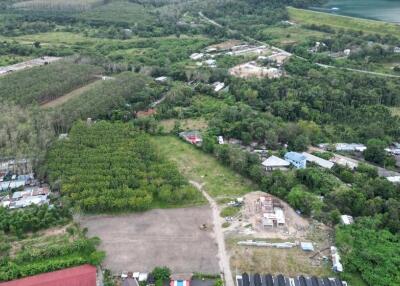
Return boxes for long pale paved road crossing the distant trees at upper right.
[199,12,400,78]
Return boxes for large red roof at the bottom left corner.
[0,264,96,286]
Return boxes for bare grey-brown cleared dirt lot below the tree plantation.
[81,207,219,273]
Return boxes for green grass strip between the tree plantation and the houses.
[153,136,255,198]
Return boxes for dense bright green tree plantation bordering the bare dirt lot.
[47,121,200,212]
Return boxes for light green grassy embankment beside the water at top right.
[287,7,400,37]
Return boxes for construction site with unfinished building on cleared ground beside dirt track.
[225,192,333,276]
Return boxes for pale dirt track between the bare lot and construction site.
[190,181,235,286]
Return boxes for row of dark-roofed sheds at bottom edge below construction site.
[236,273,347,286]
